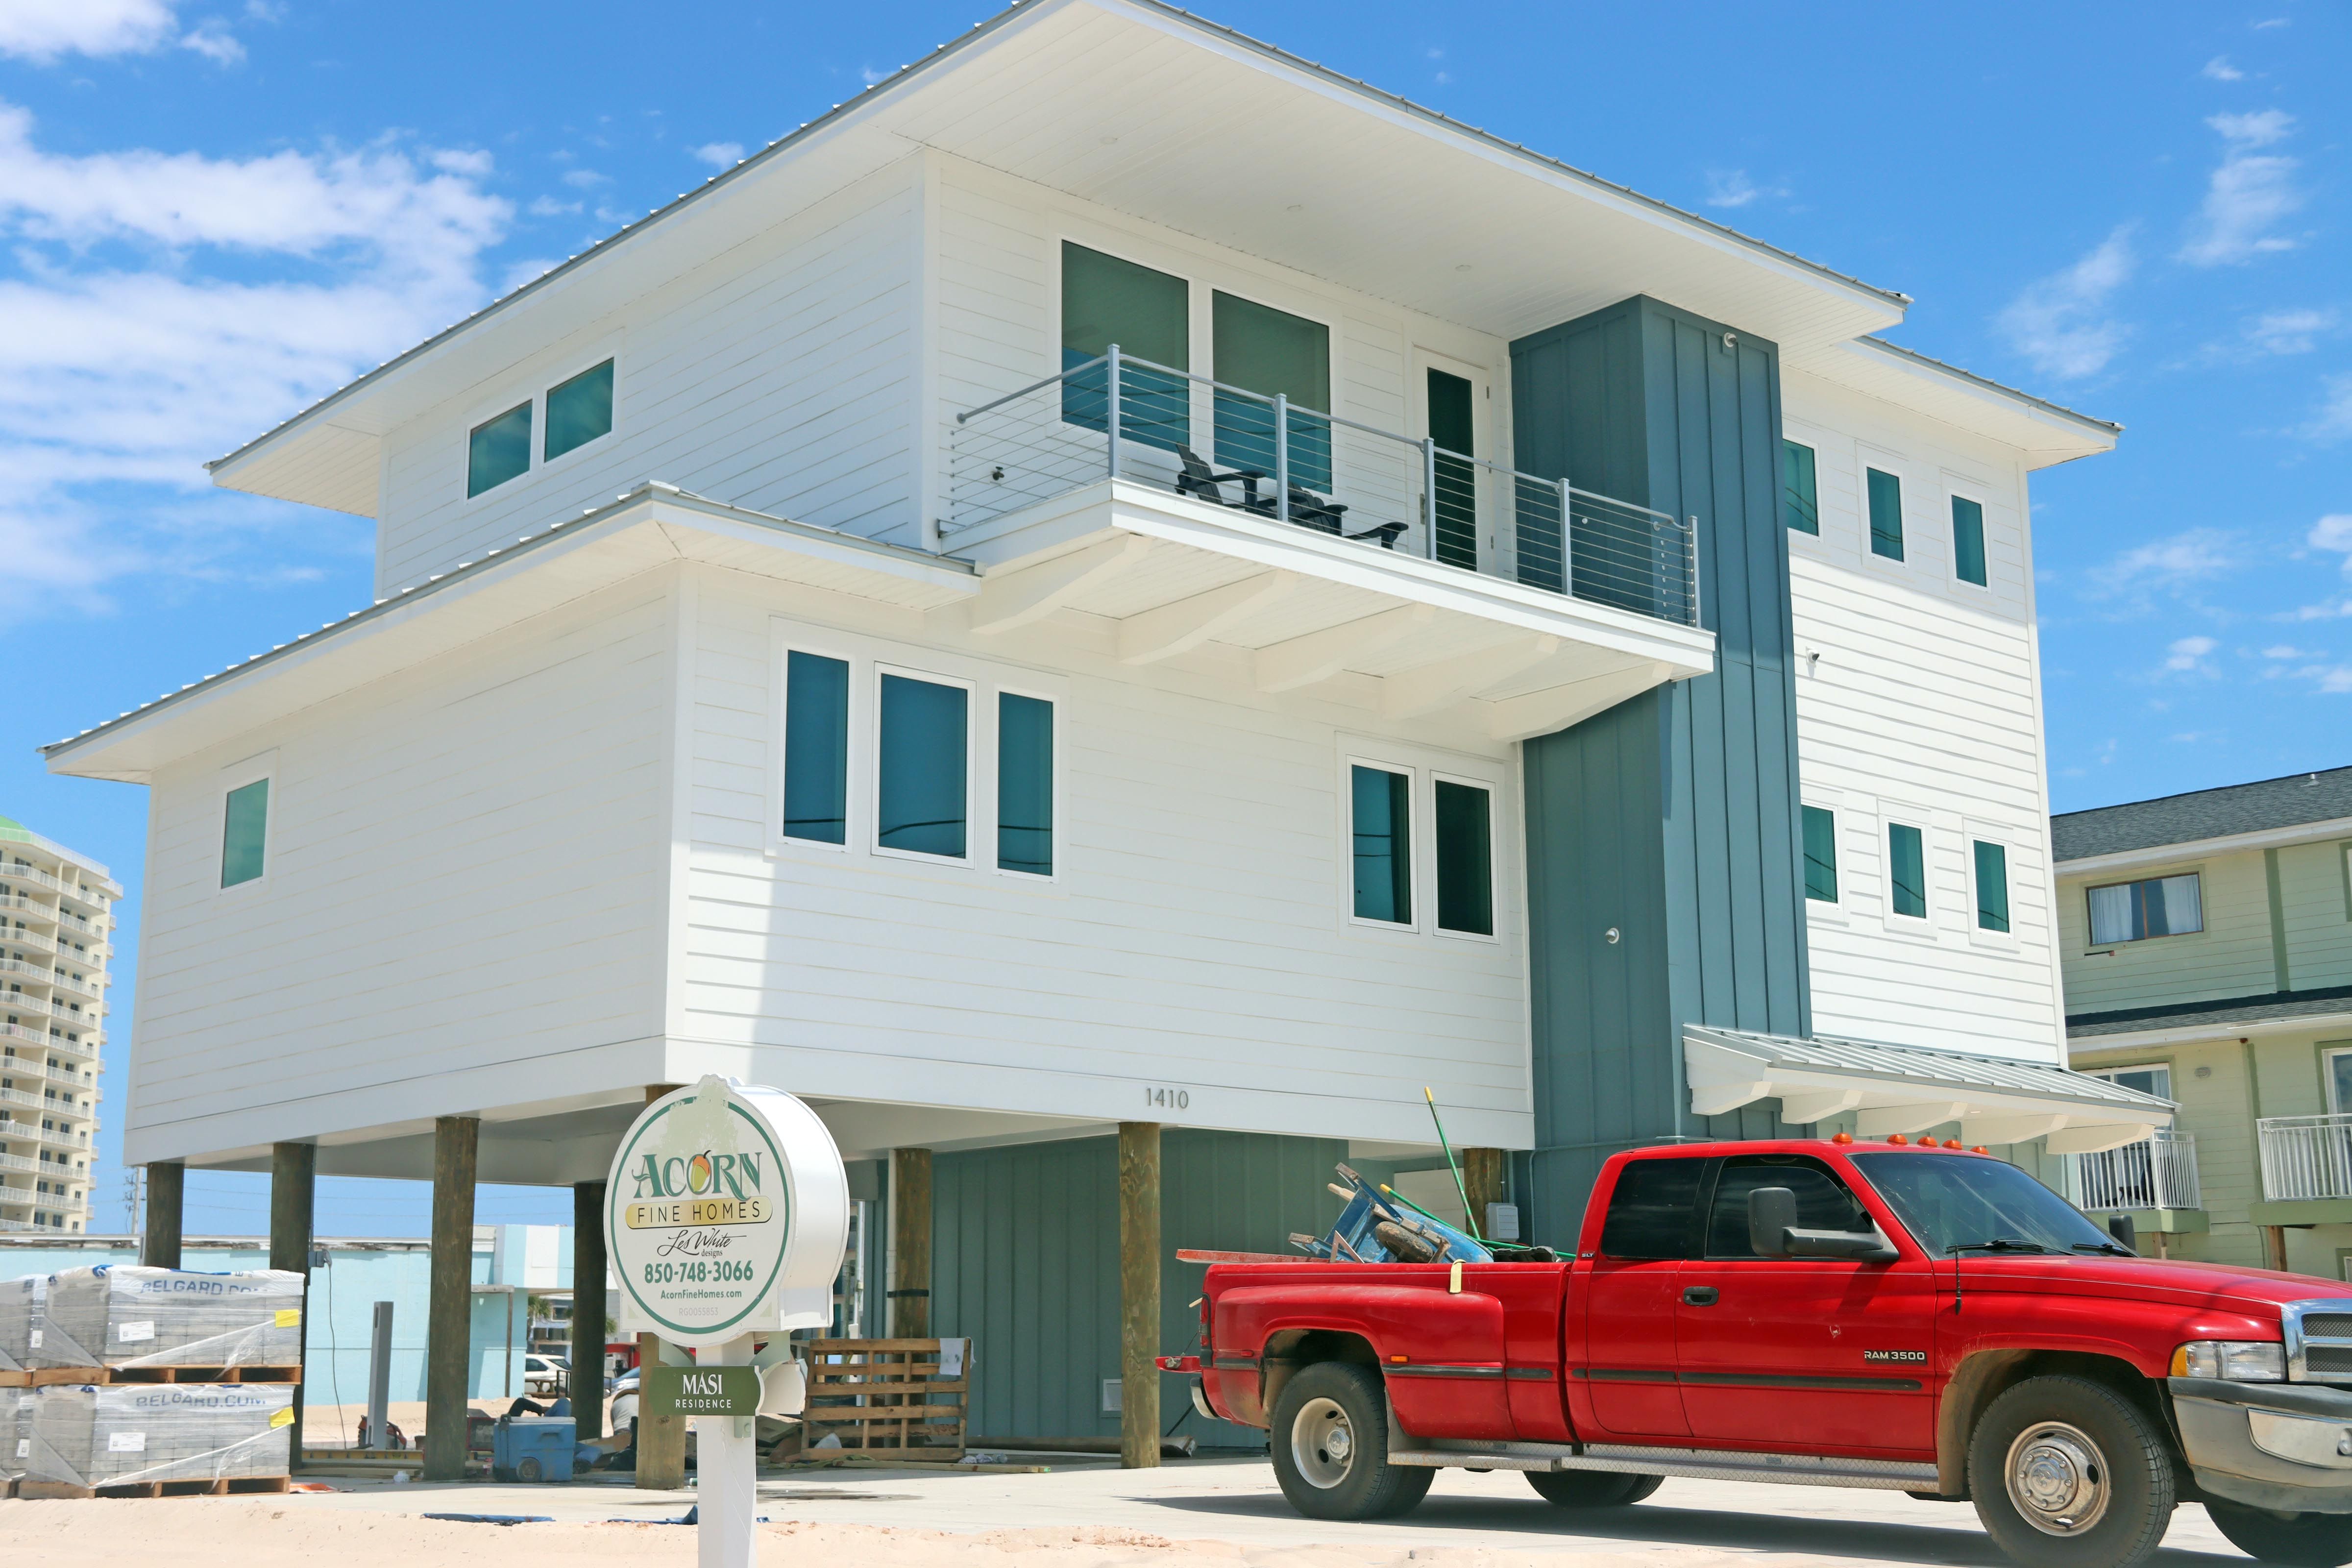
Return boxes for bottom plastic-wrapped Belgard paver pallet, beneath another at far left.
[17,1382,294,1486]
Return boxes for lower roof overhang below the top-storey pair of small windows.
[42,484,979,783]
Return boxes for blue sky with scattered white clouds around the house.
[0,0,2352,1234]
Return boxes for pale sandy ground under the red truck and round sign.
[0,1460,2246,1568]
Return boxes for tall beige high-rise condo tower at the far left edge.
[0,816,122,1232]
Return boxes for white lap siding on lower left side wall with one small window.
[129,583,673,1138]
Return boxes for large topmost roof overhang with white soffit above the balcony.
[212,0,1908,515]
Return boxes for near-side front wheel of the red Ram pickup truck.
[1969,1375,2173,1568]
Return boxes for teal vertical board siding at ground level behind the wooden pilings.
[931,1128,1348,1448]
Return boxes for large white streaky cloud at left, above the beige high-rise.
[0,103,511,604]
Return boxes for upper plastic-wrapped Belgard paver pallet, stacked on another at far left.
[26,1262,303,1368]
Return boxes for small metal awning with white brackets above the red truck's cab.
[1682,1025,2173,1154]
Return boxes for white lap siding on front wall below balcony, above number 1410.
[685,578,1529,1135]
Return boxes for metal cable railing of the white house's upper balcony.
[941,345,1698,625]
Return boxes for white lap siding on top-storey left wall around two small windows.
[376,160,920,592]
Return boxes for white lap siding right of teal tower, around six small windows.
[1785,376,2063,1060]
